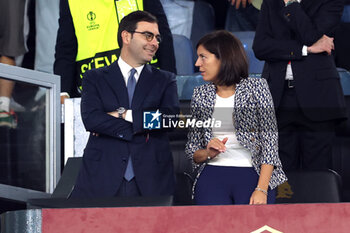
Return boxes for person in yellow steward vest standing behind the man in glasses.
[54,0,176,100]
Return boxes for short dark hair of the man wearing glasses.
[118,11,158,48]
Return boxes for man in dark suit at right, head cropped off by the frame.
[253,0,346,170]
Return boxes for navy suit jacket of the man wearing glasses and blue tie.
[72,62,179,198]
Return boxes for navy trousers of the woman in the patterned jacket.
[194,165,276,205]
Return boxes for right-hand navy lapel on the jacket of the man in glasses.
[131,64,156,108]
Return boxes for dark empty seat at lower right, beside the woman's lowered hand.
[276,170,341,203]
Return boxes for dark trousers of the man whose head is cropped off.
[276,84,335,170]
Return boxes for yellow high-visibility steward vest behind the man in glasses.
[68,0,157,88]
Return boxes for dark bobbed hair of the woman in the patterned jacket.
[196,30,248,86]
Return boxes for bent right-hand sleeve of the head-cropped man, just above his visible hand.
[282,0,343,46]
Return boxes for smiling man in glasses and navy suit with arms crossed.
[72,11,179,198]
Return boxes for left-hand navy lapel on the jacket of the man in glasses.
[104,62,129,108]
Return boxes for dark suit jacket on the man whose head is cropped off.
[253,0,346,121]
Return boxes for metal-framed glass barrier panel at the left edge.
[0,64,61,195]
